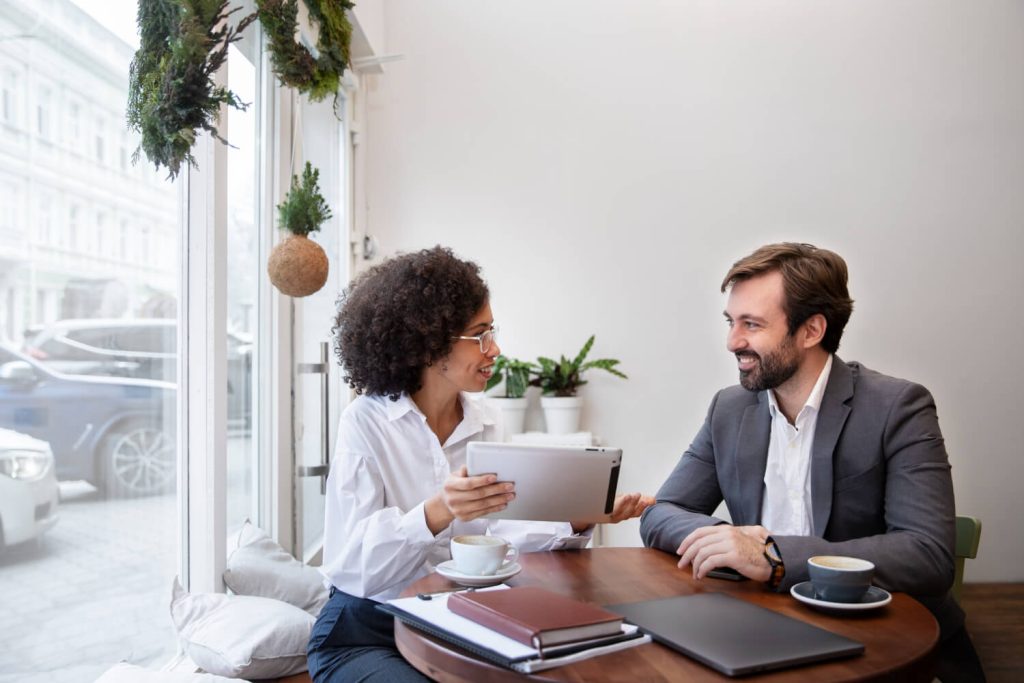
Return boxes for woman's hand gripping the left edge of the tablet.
[424,465,515,536]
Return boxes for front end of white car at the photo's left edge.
[0,429,59,550]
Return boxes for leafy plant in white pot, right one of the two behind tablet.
[530,335,627,434]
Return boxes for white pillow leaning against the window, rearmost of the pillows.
[224,520,328,615]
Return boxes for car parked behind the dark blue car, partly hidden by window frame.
[25,317,253,428]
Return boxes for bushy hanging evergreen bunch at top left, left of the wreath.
[128,0,256,178]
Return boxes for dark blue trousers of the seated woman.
[306,588,430,683]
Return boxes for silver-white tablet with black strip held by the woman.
[466,441,623,522]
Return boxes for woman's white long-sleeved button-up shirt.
[321,394,590,601]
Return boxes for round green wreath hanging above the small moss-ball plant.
[256,0,355,101]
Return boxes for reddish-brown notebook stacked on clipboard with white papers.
[379,587,650,674]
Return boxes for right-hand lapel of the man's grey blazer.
[811,356,853,538]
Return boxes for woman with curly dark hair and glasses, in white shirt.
[308,247,648,683]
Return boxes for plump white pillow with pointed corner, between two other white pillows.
[171,579,315,679]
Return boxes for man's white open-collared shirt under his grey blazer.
[761,355,833,536]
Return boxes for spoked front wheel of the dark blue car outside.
[100,421,176,498]
